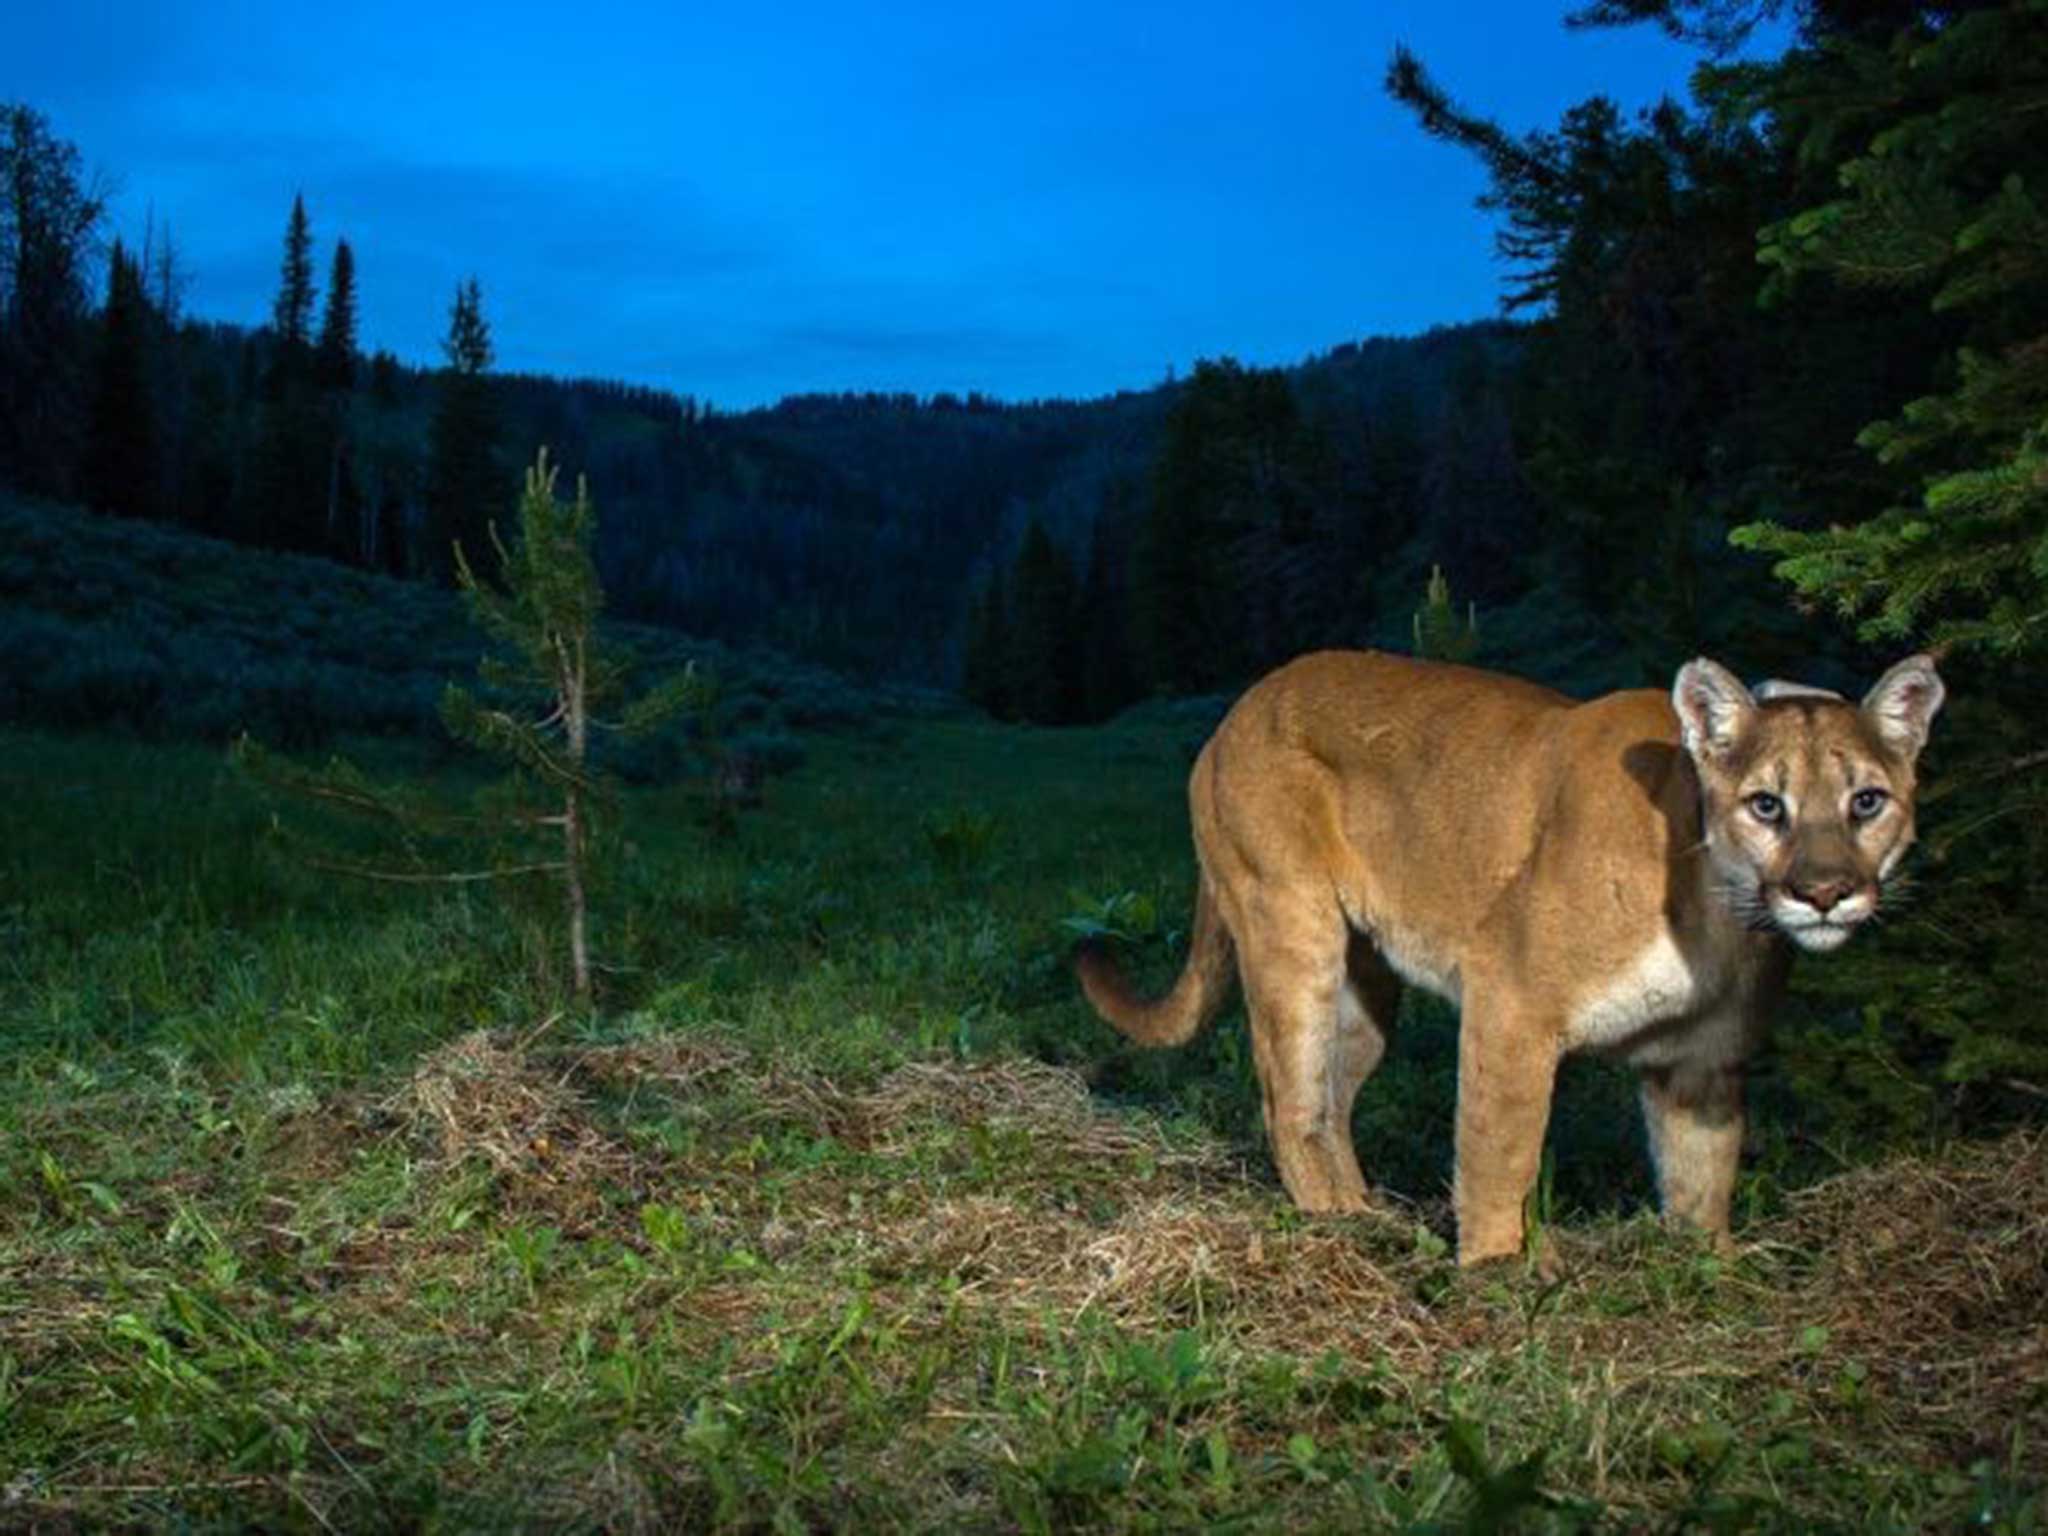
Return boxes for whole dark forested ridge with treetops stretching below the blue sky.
[0,106,1524,704]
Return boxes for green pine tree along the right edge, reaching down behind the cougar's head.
[1548,0,2048,1105]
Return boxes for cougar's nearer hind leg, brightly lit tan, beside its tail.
[1237,891,1382,1212]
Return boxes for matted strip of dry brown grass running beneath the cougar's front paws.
[364,1032,2048,1482]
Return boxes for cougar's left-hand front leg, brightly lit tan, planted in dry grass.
[1454,985,1559,1264]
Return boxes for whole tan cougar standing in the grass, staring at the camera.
[1079,651,1942,1264]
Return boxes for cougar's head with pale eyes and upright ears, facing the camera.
[1671,655,1944,952]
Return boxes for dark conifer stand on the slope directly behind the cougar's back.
[963,324,1532,723]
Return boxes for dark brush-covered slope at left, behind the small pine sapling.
[0,496,948,748]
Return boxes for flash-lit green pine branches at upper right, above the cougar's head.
[1737,0,2048,655]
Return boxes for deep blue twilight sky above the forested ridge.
[19,0,1728,408]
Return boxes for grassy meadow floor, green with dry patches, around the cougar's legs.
[0,709,2048,1532]
